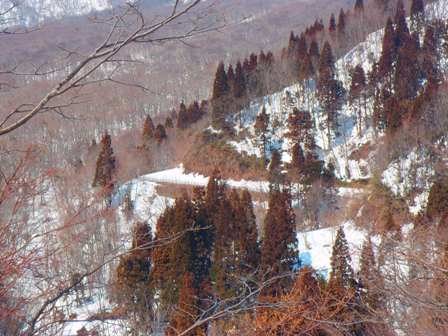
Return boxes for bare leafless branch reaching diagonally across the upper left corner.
[0,0,217,135]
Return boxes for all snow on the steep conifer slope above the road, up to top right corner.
[229,0,448,185]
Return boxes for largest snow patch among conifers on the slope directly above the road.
[229,78,374,180]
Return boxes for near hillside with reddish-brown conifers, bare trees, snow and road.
[0,0,448,336]
